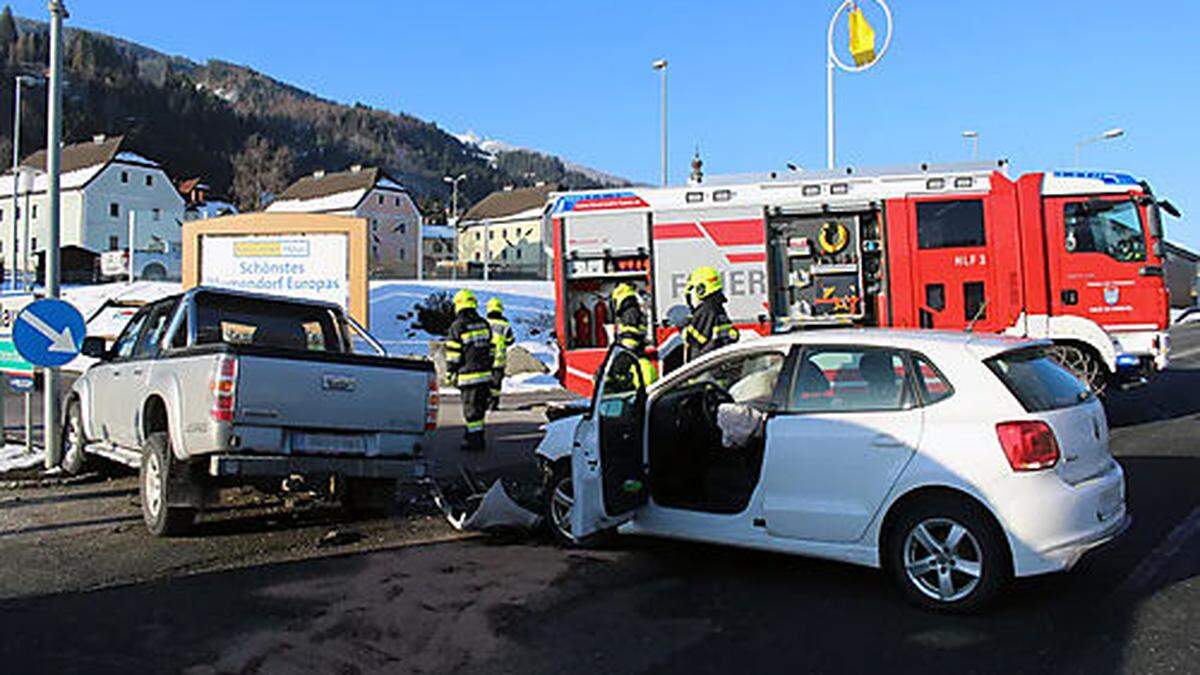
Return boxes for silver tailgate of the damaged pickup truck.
[234,352,433,434]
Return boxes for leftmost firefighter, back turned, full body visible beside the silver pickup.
[446,288,496,452]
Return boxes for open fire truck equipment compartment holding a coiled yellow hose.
[768,210,883,330]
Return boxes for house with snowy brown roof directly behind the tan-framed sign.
[266,165,421,276]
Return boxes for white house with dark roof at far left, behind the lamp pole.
[0,136,184,269]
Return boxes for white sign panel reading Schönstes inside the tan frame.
[200,233,349,309]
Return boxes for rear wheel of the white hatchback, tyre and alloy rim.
[884,495,1012,611]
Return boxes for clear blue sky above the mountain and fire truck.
[12,0,1200,249]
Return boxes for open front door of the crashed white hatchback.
[571,345,649,539]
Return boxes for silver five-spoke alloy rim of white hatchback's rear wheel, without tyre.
[904,518,983,603]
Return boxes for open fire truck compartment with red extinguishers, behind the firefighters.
[560,214,653,350]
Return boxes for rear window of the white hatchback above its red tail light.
[986,347,1092,412]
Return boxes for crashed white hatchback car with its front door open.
[536,330,1129,610]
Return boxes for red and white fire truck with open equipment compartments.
[547,162,1175,394]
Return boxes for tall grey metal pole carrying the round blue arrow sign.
[42,0,68,468]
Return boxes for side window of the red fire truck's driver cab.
[1063,199,1146,262]
